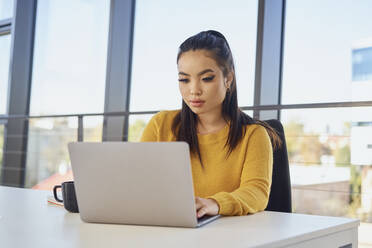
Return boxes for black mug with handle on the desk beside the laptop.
[53,181,79,213]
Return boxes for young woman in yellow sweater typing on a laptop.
[141,30,280,217]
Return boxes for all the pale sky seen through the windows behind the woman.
[0,0,372,133]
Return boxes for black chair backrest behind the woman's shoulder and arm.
[265,119,292,213]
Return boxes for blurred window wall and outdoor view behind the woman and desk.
[0,0,372,247]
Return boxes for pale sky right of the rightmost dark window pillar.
[282,0,372,135]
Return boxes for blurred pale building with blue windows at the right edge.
[350,38,372,213]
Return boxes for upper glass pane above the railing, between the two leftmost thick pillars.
[30,0,110,115]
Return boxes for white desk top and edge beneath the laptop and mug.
[0,186,359,248]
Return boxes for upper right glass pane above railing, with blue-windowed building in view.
[282,0,372,104]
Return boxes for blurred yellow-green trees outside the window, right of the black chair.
[284,120,371,221]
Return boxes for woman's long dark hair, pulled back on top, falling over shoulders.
[172,30,281,165]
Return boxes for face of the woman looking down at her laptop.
[178,50,232,115]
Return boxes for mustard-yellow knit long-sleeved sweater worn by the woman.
[141,110,273,215]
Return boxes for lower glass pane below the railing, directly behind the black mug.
[25,117,78,190]
